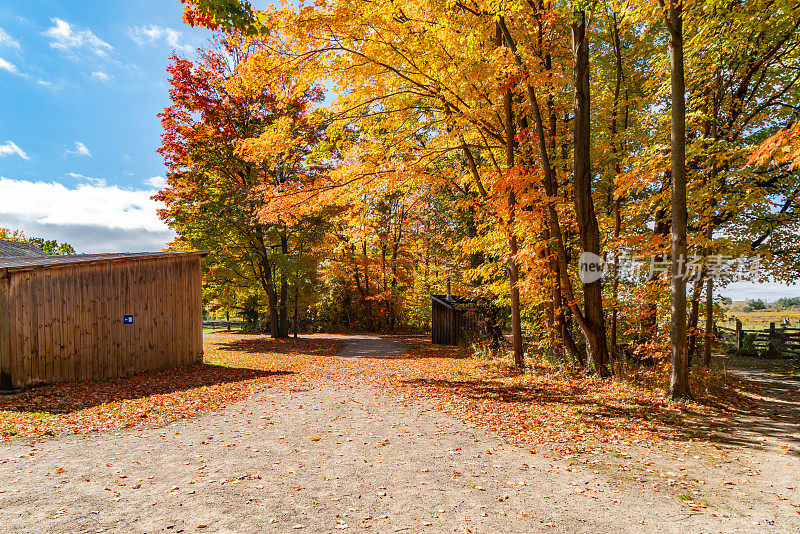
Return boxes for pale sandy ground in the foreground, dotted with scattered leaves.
[0,340,800,533]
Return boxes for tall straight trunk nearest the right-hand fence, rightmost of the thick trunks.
[667,0,690,399]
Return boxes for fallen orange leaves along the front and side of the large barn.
[0,335,341,438]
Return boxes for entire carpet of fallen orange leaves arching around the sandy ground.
[0,334,744,452]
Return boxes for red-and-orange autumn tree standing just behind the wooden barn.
[155,36,321,337]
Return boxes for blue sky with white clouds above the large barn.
[0,0,216,252]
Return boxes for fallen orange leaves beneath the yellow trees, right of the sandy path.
[298,336,742,452]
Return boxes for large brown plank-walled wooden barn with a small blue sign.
[0,252,205,389]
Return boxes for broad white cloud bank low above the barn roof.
[0,177,174,252]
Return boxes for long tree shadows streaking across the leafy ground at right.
[401,364,800,456]
